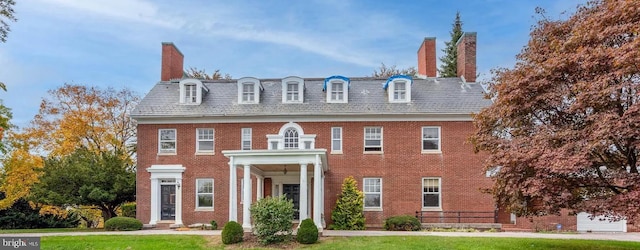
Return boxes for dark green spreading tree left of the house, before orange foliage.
[30,148,136,221]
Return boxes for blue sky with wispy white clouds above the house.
[0,0,585,127]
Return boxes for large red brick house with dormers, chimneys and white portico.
[132,33,495,229]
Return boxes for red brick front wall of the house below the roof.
[137,119,494,226]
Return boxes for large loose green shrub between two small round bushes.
[251,196,294,245]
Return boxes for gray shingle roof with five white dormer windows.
[132,78,491,119]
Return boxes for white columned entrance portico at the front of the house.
[222,149,329,231]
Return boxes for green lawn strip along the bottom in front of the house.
[33,235,640,250]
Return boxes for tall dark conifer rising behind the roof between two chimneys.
[438,11,463,77]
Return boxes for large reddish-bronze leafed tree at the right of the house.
[471,0,640,221]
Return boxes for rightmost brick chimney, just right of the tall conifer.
[456,32,476,82]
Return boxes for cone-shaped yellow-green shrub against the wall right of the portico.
[331,176,364,230]
